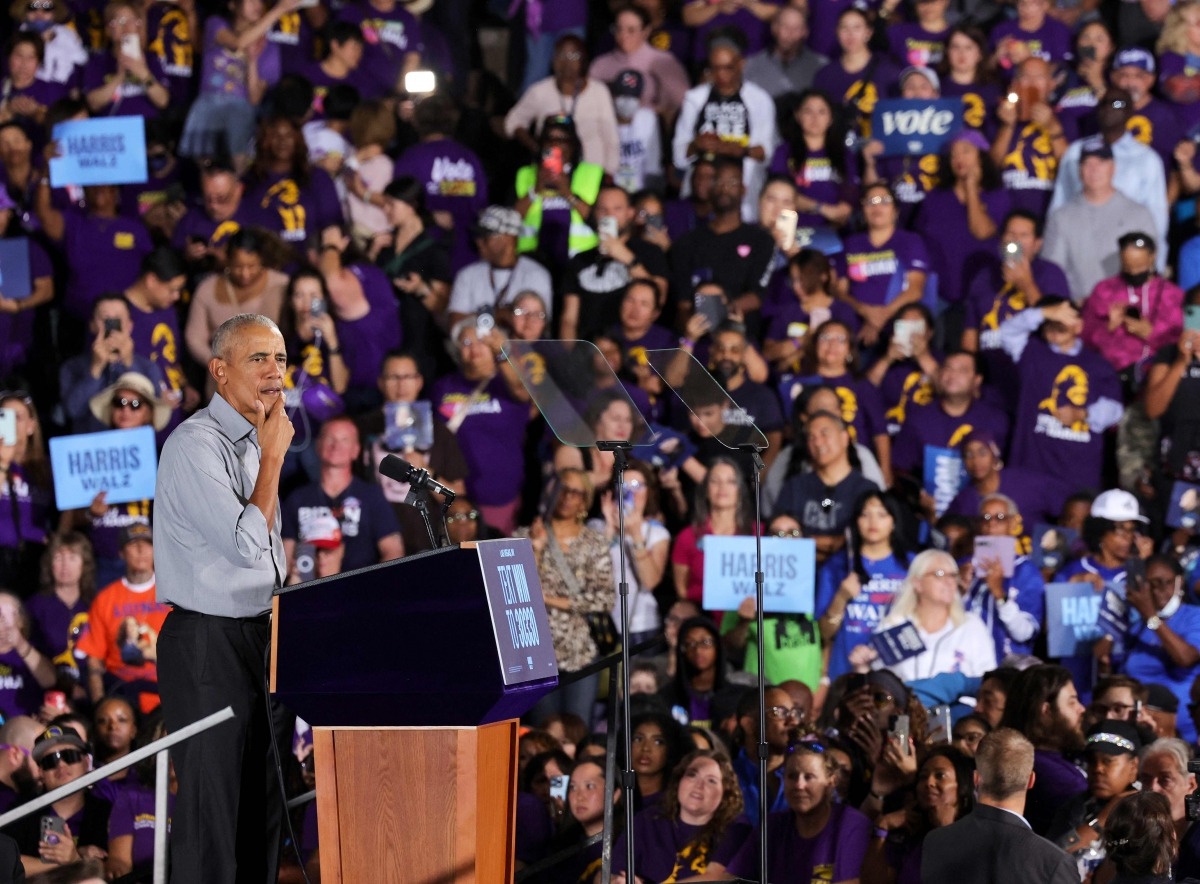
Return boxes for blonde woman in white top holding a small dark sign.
[850,549,996,681]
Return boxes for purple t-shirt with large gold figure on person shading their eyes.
[1008,337,1121,488]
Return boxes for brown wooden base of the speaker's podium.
[313,718,517,884]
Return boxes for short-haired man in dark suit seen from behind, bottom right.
[920,728,1079,884]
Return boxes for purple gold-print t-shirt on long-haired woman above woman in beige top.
[241,167,342,249]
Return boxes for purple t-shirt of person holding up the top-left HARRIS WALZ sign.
[62,210,154,321]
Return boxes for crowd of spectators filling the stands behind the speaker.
[0,0,1200,884]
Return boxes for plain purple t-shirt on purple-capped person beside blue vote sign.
[917,190,1012,303]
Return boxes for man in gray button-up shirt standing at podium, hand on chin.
[154,314,293,884]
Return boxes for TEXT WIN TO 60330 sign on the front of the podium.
[475,537,558,685]
